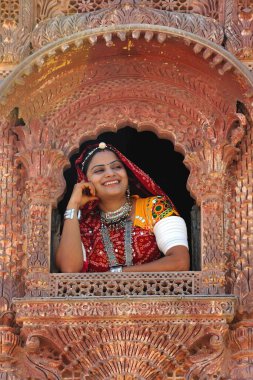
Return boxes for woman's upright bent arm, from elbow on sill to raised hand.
[56,182,97,273]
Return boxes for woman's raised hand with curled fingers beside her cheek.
[67,181,98,210]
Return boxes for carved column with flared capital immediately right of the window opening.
[184,114,245,294]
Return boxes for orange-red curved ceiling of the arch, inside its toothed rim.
[11,39,239,123]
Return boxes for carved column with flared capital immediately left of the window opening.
[15,120,68,296]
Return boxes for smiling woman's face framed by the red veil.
[87,150,128,200]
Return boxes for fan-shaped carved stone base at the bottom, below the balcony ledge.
[11,302,233,380]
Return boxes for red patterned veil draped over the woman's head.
[75,143,172,214]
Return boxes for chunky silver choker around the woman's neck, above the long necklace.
[100,200,132,229]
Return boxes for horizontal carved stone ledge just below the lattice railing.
[15,297,235,322]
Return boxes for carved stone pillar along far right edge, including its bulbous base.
[227,118,253,380]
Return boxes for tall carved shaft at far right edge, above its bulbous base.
[230,117,253,315]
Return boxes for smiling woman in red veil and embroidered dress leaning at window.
[56,143,189,272]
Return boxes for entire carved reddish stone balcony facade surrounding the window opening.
[0,0,253,380]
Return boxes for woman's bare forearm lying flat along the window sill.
[123,245,190,272]
